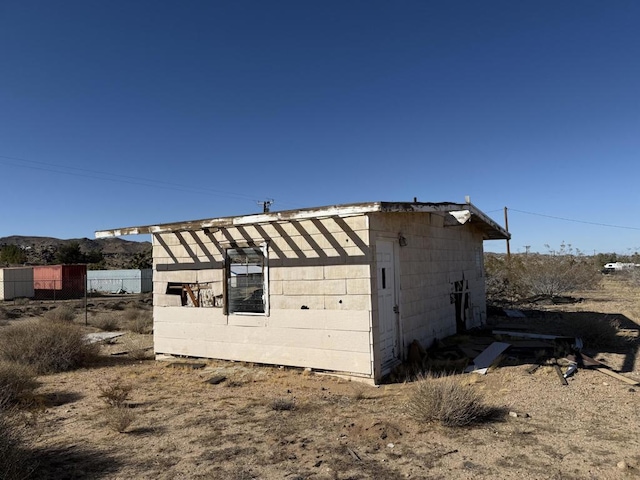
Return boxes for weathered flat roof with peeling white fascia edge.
[95,202,511,240]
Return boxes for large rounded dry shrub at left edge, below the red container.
[0,319,99,373]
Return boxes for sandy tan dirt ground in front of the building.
[5,277,640,480]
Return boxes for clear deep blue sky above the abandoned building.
[0,0,640,253]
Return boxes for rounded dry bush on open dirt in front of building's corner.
[405,376,501,427]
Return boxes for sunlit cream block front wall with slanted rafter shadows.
[153,216,373,377]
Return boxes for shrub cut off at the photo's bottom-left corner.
[0,409,34,480]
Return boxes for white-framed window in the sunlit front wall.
[225,245,268,314]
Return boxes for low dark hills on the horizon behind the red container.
[0,235,151,269]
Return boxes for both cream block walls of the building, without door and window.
[153,212,486,380]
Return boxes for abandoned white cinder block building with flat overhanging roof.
[96,202,509,382]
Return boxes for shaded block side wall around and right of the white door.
[371,213,486,354]
